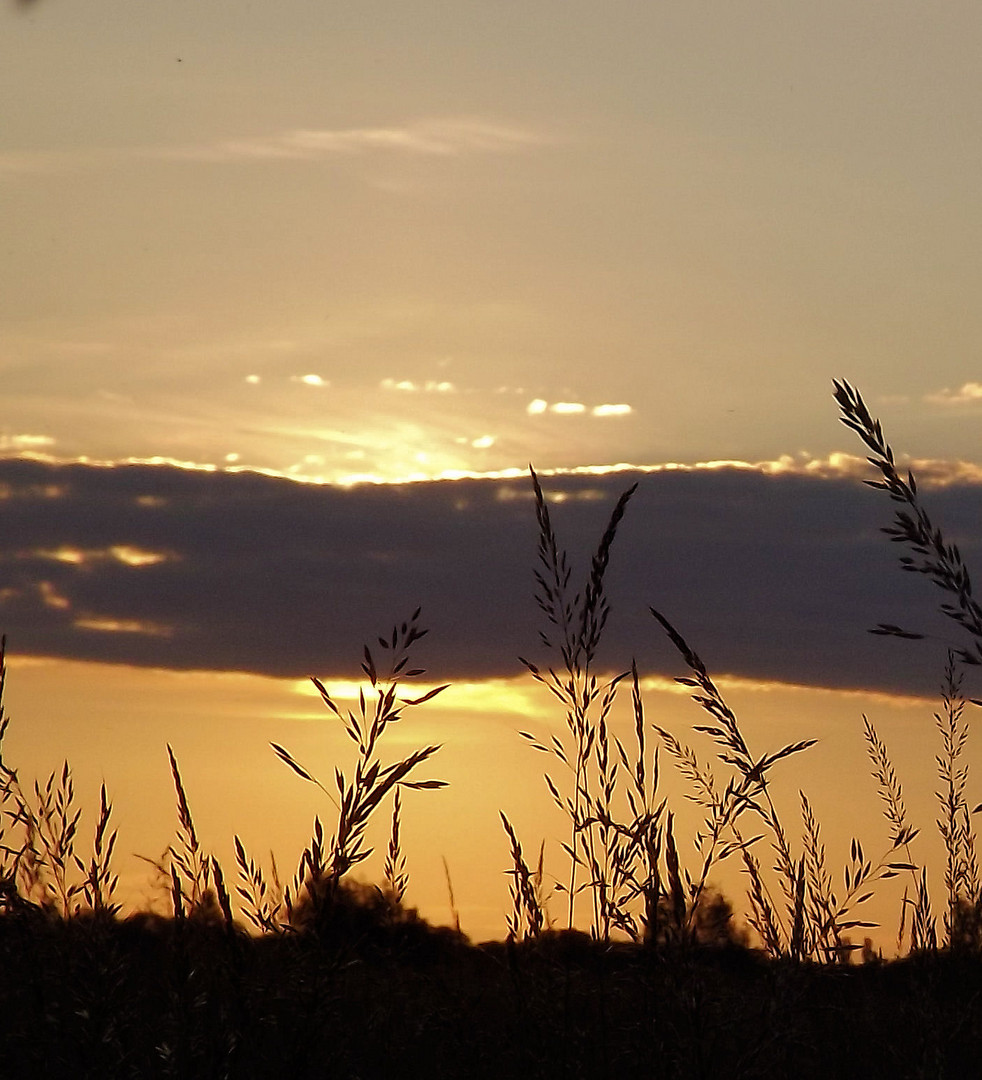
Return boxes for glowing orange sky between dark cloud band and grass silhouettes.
[4,656,954,940]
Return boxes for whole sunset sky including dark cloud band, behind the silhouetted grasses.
[0,0,982,934]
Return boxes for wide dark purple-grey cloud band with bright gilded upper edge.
[0,458,982,692]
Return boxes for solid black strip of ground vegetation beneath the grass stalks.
[0,902,982,1080]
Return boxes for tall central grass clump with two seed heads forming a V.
[509,470,691,941]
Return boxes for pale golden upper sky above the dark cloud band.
[0,0,982,480]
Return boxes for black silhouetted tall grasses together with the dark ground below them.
[0,383,982,1080]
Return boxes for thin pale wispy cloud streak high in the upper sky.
[154,119,550,161]
